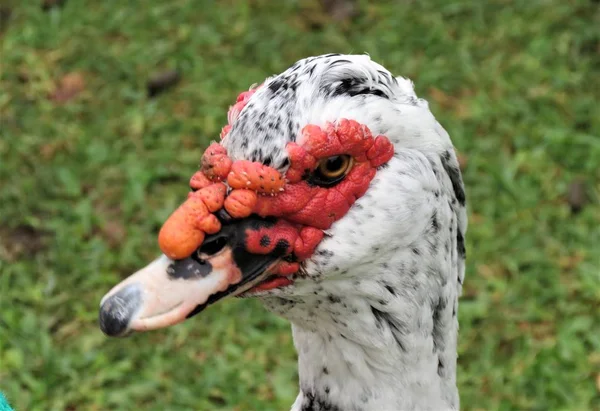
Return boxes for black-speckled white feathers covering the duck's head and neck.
[225,55,467,411]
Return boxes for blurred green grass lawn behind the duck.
[0,0,600,411]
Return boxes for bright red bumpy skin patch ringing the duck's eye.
[254,119,394,230]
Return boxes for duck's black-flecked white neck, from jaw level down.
[265,256,459,411]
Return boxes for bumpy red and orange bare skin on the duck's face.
[159,89,394,291]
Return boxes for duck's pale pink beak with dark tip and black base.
[99,217,282,337]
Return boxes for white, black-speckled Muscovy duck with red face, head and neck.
[100,54,467,411]
